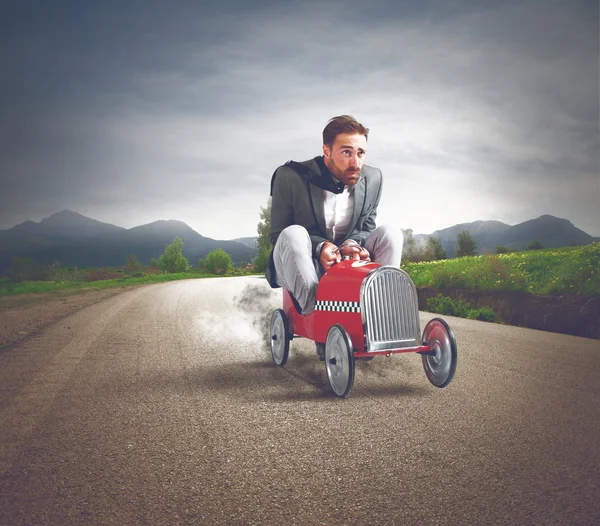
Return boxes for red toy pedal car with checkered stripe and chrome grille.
[270,260,457,398]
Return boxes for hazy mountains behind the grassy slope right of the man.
[415,215,600,257]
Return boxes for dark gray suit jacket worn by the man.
[266,157,382,287]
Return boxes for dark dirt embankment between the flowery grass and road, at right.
[418,288,600,338]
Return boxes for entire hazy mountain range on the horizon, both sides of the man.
[0,210,600,271]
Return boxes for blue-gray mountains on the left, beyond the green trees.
[0,210,256,272]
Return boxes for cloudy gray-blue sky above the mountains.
[0,0,600,239]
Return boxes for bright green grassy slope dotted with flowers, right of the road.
[402,243,600,296]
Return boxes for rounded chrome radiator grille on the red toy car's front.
[360,266,421,351]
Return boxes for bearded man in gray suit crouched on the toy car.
[266,115,402,322]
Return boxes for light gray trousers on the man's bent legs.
[273,225,404,314]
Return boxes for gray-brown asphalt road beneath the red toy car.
[0,278,600,525]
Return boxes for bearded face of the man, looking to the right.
[323,133,367,186]
